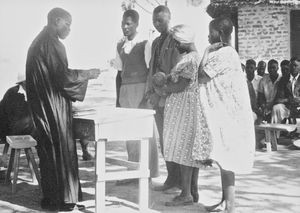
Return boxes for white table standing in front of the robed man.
[74,107,155,212]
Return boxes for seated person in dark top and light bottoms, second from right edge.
[271,60,292,123]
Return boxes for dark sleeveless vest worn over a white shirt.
[117,41,148,84]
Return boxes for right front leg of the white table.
[139,138,149,212]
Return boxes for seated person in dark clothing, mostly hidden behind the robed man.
[0,73,91,161]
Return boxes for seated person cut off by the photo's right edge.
[288,57,300,123]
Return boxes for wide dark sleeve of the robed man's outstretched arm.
[47,41,90,101]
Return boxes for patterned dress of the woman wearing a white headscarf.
[163,52,201,167]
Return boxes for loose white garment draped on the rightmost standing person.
[193,46,255,173]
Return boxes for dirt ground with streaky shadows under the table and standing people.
[0,136,300,213]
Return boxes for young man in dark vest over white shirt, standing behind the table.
[112,10,158,184]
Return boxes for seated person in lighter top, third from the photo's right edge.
[257,59,280,123]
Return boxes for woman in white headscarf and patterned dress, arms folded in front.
[155,25,201,206]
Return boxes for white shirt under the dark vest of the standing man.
[112,34,151,71]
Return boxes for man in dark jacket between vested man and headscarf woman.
[147,5,181,191]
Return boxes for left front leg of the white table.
[95,139,107,212]
